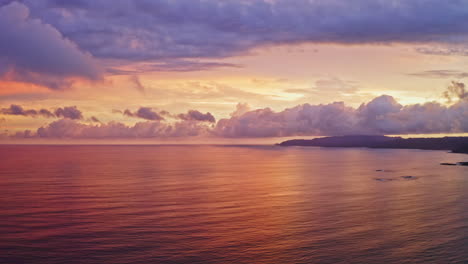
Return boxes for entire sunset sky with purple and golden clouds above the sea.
[0,0,468,143]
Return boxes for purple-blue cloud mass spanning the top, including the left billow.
[0,0,468,86]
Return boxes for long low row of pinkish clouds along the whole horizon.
[9,92,468,138]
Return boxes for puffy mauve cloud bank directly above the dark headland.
[213,91,468,137]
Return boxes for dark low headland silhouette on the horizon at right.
[277,135,468,154]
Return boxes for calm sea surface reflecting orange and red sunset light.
[0,146,468,264]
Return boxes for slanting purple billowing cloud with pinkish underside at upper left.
[0,2,100,89]
